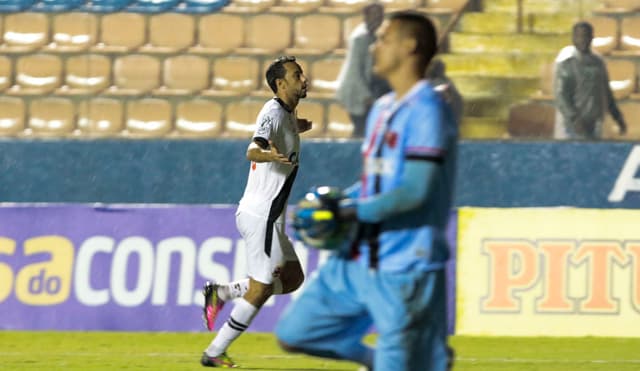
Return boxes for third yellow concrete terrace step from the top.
[449,32,571,54]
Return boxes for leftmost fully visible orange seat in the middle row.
[7,54,62,95]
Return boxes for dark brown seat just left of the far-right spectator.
[507,102,555,139]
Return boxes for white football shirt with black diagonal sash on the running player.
[238,98,300,222]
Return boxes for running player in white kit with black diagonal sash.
[200,56,311,368]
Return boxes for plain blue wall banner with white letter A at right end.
[0,139,640,209]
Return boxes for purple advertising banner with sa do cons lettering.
[0,204,456,332]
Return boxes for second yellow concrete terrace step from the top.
[457,12,580,34]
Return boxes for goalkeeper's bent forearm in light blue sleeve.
[340,160,439,223]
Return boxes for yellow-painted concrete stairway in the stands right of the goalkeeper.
[443,0,600,139]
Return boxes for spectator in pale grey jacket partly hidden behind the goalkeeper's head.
[336,2,390,138]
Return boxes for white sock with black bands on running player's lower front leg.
[205,298,260,357]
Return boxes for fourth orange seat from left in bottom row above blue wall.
[123,98,172,138]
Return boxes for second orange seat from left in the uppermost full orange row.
[47,13,98,52]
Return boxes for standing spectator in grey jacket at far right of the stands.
[553,22,627,139]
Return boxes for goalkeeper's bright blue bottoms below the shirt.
[275,257,447,371]
